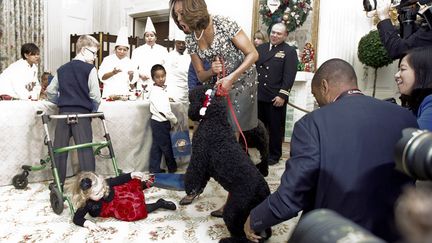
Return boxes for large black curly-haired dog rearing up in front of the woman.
[185,85,271,242]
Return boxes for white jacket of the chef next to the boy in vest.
[98,54,136,98]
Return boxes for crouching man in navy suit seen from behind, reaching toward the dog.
[245,59,418,242]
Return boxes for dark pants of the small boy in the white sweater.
[149,119,177,173]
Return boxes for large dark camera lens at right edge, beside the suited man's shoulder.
[395,128,432,180]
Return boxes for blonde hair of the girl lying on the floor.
[72,171,109,209]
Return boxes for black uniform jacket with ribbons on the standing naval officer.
[255,42,298,102]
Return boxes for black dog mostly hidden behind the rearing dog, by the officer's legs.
[239,120,269,177]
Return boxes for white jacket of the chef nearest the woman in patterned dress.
[165,50,191,103]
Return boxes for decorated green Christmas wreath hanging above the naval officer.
[259,0,312,32]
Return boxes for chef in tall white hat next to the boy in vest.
[98,27,136,98]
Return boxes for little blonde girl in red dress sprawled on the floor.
[72,171,176,231]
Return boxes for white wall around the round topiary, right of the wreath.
[317,0,398,98]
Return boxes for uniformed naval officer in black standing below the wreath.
[256,23,298,165]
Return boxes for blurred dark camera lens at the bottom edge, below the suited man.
[288,209,385,243]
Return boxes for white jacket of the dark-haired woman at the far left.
[0,58,40,100]
